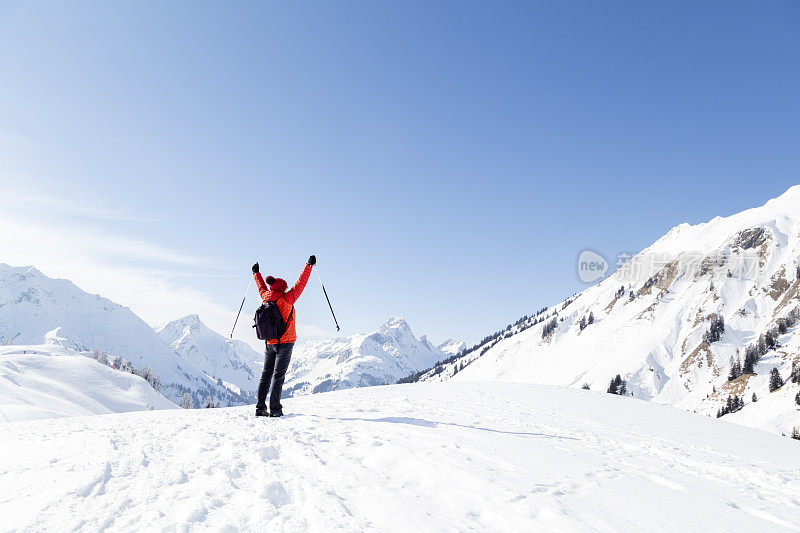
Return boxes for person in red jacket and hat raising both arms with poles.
[253,255,317,417]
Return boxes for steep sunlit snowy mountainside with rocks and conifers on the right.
[419,186,800,434]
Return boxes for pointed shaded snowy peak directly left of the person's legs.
[156,315,264,394]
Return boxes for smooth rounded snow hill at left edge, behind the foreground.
[0,345,177,422]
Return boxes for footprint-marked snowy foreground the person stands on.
[0,383,800,533]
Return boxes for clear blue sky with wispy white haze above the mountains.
[0,0,800,348]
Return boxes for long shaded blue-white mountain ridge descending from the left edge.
[0,263,249,404]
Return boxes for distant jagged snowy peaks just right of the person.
[283,317,463,396]
